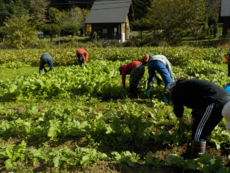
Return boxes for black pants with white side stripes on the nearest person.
[192,103,224,141]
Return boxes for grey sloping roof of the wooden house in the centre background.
[85,0,132,24]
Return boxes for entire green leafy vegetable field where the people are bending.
[0,47,230,173]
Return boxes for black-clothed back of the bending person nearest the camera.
[172,79,230,110]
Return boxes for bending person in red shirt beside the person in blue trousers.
[119,61,145,98]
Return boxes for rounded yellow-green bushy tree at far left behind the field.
[3,14,37,49]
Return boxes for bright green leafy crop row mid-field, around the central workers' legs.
[0,60,228,101]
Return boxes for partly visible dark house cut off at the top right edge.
[219,0,230,36]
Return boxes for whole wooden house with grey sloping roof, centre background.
[85,0,135,42]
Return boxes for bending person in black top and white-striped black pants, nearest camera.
[168,78,230,158]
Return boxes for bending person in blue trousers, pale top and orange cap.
[143,53,173,103]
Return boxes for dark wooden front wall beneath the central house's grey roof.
[91,23,121,40]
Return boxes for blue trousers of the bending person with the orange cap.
[148,61,172,88]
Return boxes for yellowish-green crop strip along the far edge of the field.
[0,47,228,66]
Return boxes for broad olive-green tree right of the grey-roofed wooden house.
[147,0,207,40]
